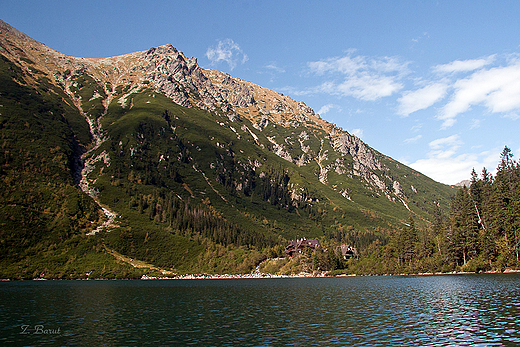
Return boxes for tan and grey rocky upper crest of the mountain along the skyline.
[0,25,430,204]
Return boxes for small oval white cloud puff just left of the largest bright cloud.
[397,82,448,117]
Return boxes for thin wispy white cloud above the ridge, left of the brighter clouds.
[308,51,408,101]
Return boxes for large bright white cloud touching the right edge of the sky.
[386,54,520,129]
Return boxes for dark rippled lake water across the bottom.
[0,274,520,347]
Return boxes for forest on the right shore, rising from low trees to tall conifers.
[344,146,520,274]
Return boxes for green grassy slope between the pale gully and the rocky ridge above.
[88,90,447,266]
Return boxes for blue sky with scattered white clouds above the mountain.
[0,0,520,184]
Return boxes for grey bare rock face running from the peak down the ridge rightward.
[122,45,402,199]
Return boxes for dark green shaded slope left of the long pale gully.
[0,56,152,278]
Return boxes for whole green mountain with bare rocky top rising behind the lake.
[0,21,454,278]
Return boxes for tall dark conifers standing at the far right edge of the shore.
[447,146,520,268]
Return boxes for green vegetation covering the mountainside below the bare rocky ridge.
[0,47,464,279]
